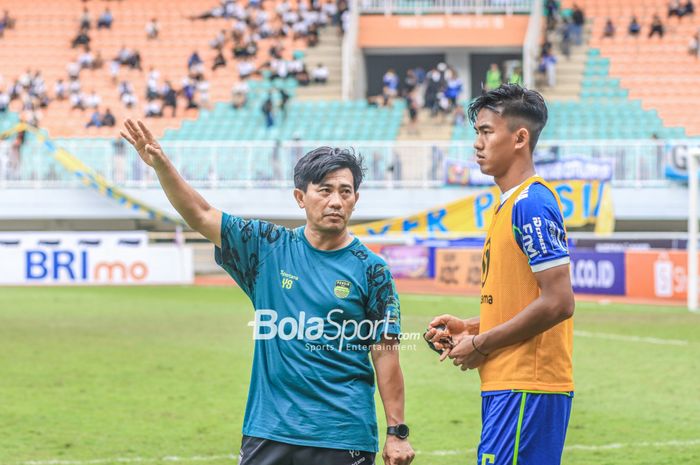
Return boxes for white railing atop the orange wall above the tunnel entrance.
[359,0,533,15]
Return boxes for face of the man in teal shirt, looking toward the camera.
[294,168,360,234]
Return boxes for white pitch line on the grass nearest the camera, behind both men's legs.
[16,439,700,465]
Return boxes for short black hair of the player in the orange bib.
[468,84,548,153]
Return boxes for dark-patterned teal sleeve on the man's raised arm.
[214,213,288,299]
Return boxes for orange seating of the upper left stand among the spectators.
[0,0,350,137]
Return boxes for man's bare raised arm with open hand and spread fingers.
[121,119,221,247]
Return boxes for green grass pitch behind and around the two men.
[0,287,700,465]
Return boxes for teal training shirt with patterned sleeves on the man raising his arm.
[215,213,400,452]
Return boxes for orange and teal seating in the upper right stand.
[562,0,700,137]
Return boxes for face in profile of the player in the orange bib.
[474,108,515,178]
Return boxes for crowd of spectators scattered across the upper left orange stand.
[0,0,348,132]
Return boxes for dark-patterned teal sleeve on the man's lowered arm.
[366,259,401,342]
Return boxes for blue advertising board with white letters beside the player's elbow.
[571,251,626,295]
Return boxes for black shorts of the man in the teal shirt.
[238,436,376,465]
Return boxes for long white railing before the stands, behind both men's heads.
[0,139,698,189]
